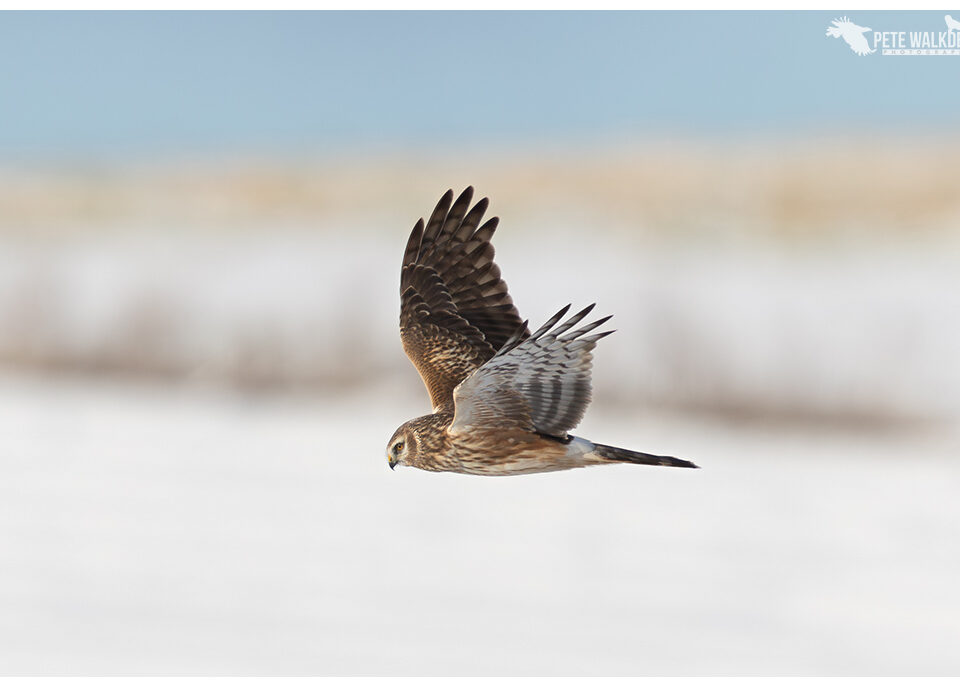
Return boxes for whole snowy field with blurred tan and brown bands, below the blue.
[0,153,960,675]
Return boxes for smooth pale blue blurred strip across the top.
[0,10,960,164]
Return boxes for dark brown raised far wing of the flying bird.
[400,186,529,410]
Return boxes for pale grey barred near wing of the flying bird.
[449,305,612,439]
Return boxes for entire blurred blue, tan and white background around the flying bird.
[0,12,960,674]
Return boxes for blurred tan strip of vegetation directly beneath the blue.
[0,139,960,237]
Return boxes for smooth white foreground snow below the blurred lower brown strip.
[0,375,960,674]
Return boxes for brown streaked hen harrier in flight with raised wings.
[387,187,697,475]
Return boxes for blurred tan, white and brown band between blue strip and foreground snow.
[0,139,960,426]
